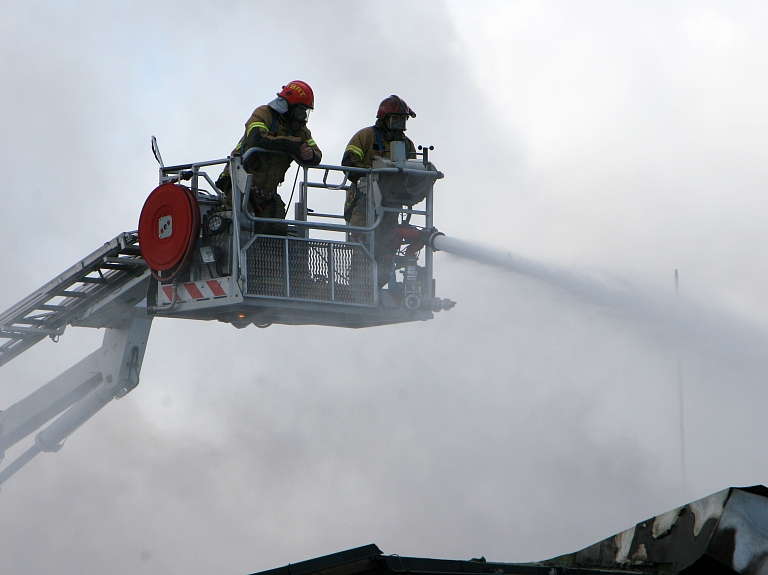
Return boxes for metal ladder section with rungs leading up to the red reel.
[0,232,146,366]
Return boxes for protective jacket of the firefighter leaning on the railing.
[220,106,323,194]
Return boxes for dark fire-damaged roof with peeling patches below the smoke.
[246,485,768,575]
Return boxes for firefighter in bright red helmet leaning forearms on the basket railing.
[216,80,323,233]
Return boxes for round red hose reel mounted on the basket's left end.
[139,183,200,282]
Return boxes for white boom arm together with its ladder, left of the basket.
[0,233,152,484]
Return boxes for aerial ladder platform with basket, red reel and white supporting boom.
[0,137,455,485]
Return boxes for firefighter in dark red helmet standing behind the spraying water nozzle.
[341,94,416,281]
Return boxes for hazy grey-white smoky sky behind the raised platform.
[0,0,768,575]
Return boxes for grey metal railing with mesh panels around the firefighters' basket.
[160,148,443,305]
